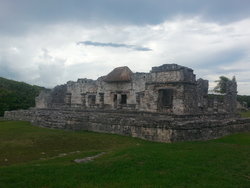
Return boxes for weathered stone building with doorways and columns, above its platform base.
[36,64,237,114]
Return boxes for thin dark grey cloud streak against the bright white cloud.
[76,41,152,51]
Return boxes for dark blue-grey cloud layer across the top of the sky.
[0,0,250,34]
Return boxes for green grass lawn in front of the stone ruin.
[0,121,250,188]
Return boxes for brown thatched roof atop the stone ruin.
[104,66,133,82]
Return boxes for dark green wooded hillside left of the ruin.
[0,77,44,116]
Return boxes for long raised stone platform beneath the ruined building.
[4,109,250,142]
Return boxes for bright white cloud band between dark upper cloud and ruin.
[0,17,250,94]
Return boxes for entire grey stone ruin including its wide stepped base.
[5,64,250,142]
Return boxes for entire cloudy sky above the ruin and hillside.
[0,0,250,95]
